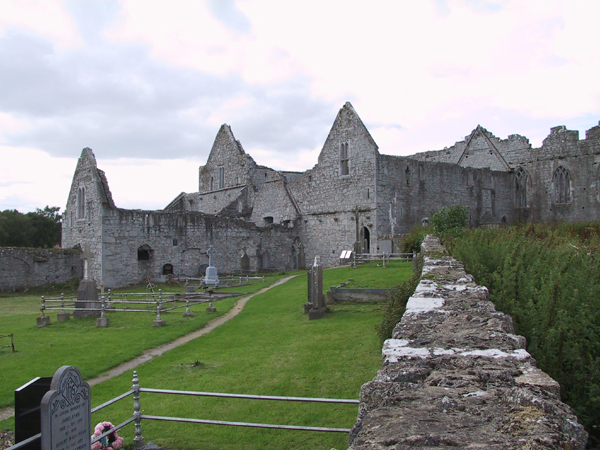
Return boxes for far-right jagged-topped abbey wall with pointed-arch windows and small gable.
[409,121,600,227]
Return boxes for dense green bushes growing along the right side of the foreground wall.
[452,223,600,448]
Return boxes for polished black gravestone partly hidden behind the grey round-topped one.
[15,377,52,450]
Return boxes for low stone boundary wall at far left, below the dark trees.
[0,247,83,292]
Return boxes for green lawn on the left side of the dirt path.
[0,275,282,407]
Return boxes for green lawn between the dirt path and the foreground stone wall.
[0,262,412,450]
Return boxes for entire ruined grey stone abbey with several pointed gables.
[62,103,600,287]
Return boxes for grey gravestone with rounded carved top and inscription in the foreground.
[40,366,92,450]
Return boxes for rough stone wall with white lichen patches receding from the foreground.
[349,237,587,450]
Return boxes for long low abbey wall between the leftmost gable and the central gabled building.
[102,209,295,287]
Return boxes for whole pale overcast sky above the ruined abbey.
[0,0,600,212]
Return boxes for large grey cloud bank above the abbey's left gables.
[0,27,341,162]
